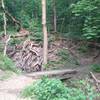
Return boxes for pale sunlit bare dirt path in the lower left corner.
[0,75,33,100]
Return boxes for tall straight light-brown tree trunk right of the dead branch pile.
[42,0,48,65]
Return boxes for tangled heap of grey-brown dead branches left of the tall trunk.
[10,40,43,72]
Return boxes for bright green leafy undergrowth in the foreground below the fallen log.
[22,77,95,100]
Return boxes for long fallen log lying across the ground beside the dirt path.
[26,69,77,77]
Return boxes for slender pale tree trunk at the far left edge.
[1,0,7,56]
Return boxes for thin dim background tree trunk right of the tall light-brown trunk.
[53,0,57,32]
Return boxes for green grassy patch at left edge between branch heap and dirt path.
[0,53,20,73]
